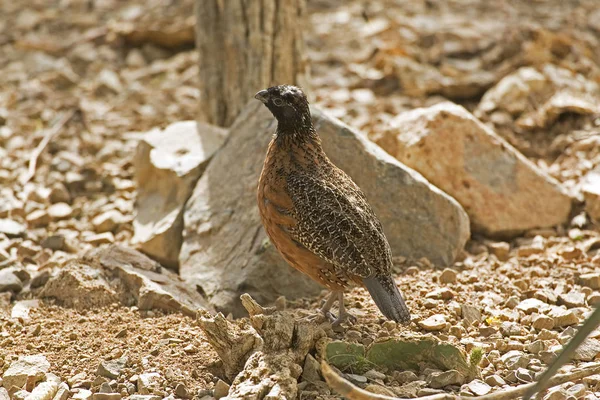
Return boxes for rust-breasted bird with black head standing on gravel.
[255,85,411,325]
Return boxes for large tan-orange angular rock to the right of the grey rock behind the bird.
[377,102,571,236]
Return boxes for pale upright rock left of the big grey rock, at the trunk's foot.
[133,121,226,269]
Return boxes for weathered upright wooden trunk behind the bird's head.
[196,0,308,127]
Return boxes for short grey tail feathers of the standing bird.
[363,275,410,324]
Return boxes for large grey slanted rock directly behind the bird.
[180,102,469,315]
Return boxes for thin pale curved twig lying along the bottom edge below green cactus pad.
[321,361,600,400]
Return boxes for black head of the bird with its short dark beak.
[254,85,312,131]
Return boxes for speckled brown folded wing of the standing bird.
[287,170,392,277]
